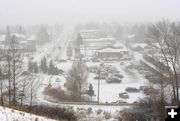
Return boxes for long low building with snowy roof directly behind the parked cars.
[95,46,130,61]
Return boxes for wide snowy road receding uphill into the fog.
[33,25,74,62]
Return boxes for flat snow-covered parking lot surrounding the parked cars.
[87,62,149,103]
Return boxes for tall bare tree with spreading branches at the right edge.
[148,20,180,103]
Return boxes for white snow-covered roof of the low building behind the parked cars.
[97,47,128,52]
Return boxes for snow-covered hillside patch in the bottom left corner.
[0,106,55,121]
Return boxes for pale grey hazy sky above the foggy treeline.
[0,0,180,25]
